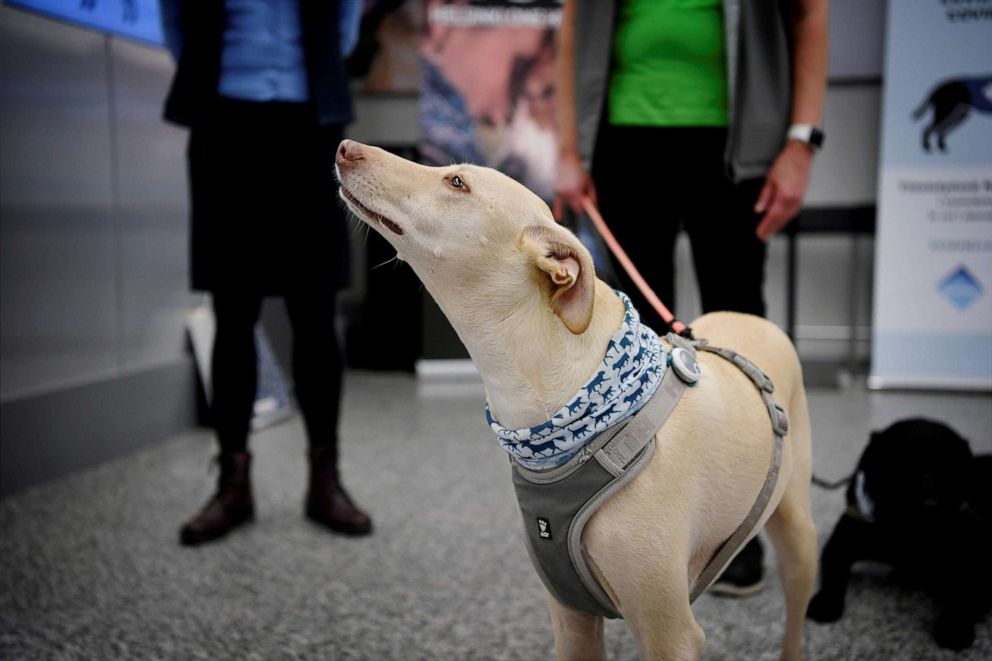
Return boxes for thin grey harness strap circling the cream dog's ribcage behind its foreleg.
[689,344,789,603]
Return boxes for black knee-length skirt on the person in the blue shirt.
[188,99,350,295]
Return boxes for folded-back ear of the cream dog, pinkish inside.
[519,225,596,335]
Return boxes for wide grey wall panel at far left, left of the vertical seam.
[0,8,118,399]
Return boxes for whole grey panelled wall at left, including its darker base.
[0,7,202,492]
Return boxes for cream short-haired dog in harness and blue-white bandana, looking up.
[337,140,816,659]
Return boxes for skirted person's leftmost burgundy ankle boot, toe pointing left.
[179,452,255,546]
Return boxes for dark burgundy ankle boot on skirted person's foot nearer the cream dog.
[306,446,372,535]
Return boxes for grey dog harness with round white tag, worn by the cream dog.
[513,334,789,618]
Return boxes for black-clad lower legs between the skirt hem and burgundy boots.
[211,286,343,452]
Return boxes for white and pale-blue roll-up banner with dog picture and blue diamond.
[872,0,992,390]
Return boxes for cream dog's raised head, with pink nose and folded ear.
[336,140,595,334]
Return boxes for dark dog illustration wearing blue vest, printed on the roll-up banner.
[913,74,992,153]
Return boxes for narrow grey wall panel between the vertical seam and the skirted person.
[111,39,200,370]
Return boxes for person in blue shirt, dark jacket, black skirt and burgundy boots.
[161,0,372,545]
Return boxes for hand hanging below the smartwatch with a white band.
[754,140,813,242]
